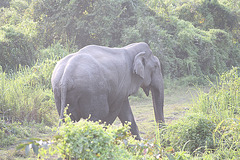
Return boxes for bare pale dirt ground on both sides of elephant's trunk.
[115,87,200,139]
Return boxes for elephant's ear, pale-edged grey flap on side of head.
[133,52,146,78]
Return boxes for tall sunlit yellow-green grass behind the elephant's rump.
[0,44,68,147]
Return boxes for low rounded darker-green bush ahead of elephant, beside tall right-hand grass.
[163,114,216,153]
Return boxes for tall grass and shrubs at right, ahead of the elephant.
[161,67,240,159]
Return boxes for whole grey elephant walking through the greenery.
[51,42,164,139]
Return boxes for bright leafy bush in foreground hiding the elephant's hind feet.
[37,115,133,159]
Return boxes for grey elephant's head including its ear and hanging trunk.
[133,49,165,123]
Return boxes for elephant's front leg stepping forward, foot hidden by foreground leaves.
[118,99,141,140]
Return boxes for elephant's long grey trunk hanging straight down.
[151,78,165,123]
